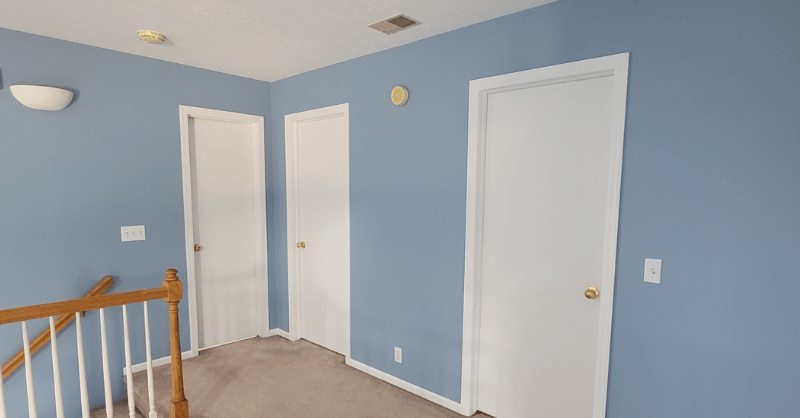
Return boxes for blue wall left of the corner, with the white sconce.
[0,29,271,417]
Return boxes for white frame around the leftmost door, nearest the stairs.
[179,105,269,356]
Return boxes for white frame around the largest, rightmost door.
[459,53,629,418]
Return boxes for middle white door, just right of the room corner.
[286,105,350,355]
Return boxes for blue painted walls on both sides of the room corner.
[0,0,800,418]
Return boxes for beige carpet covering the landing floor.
[129,337,487,418]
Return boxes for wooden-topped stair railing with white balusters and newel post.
[0,269,189,418]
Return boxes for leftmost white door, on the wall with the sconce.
[182,109,266,348]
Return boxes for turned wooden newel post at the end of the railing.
[164,269,189,418]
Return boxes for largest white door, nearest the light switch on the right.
[466,54,621,418]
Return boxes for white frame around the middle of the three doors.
[284,103,350,359]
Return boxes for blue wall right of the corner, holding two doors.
[270,0,800,418]
